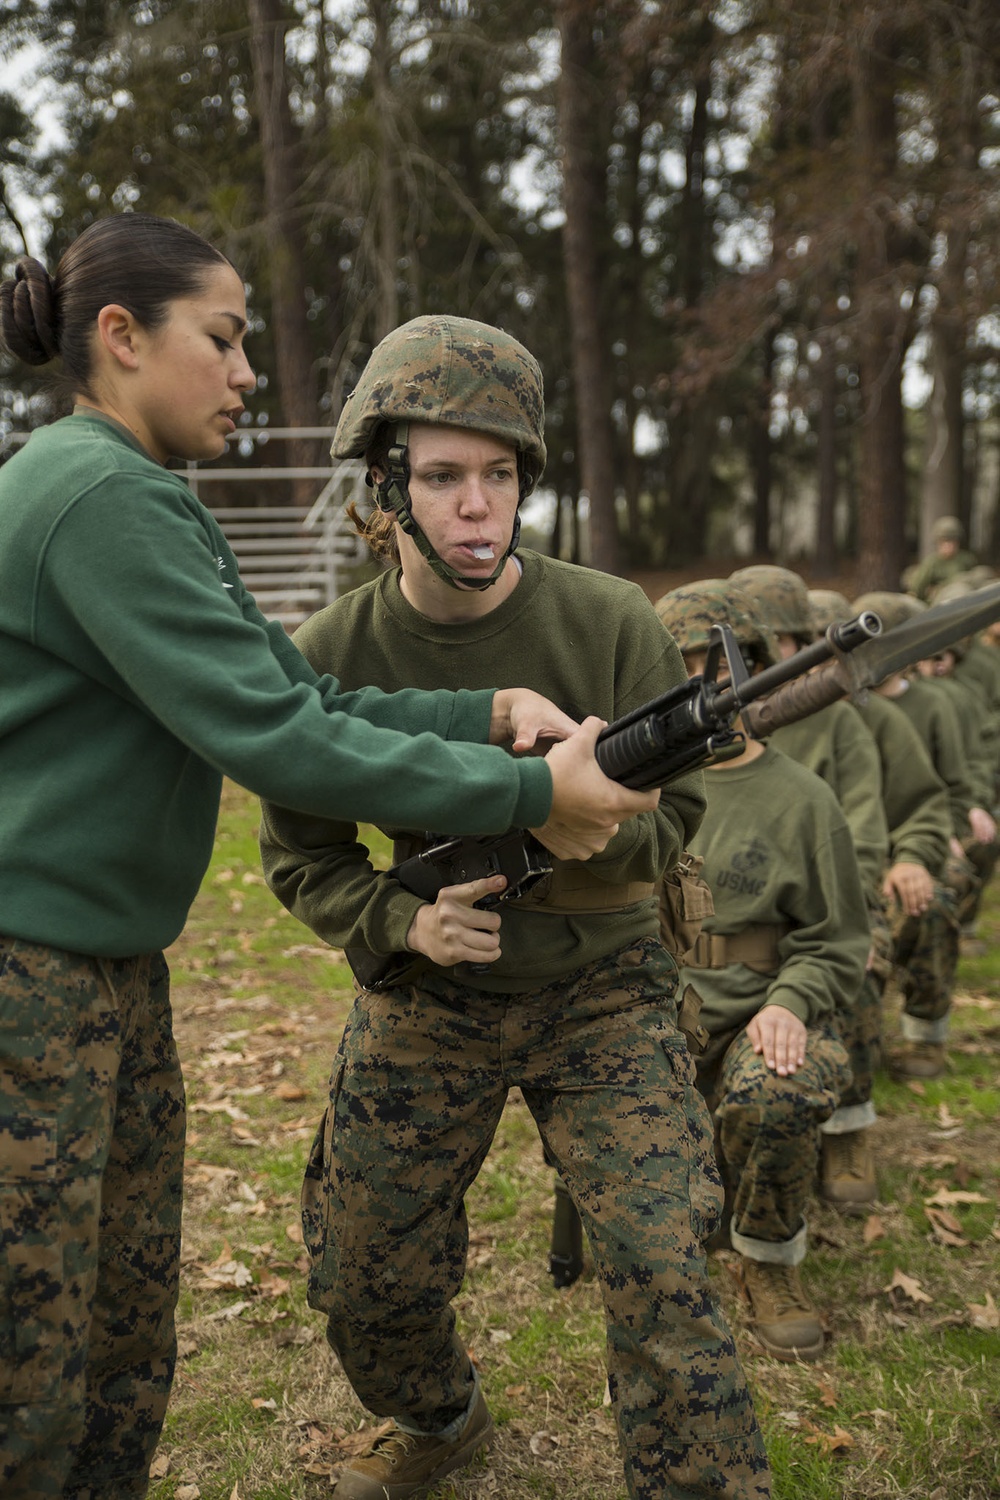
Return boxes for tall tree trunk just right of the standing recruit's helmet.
[556,0,621,573]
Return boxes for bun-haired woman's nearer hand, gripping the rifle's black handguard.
[531,717,660,860]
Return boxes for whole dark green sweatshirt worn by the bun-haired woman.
[0,414,552,957]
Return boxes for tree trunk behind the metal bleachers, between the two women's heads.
[249,0,319,504]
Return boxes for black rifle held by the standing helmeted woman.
[345,612,882,990]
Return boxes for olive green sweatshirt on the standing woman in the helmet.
[261,552,703,993]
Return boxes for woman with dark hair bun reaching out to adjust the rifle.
[0,215,657,1500]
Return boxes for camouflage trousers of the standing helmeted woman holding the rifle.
[303,942,771,1500]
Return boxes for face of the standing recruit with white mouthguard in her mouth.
[400,423,517,578]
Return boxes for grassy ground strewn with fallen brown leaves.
[151,788,1000,1500]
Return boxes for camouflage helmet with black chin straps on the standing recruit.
[330,315,546,588]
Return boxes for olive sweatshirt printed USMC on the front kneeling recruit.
[681,744,870,1037]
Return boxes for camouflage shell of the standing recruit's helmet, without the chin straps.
[330,315,546,482]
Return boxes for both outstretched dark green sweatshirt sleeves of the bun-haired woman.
[33,471,552,833]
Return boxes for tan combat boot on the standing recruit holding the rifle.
[333,1391,493,1500]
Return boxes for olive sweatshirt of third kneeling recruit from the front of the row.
[855,693,952,876]
